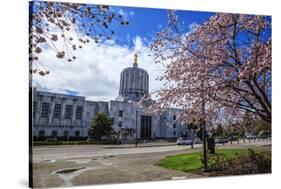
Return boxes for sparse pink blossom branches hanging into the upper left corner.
[29,1,129,76]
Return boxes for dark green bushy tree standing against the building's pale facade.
[88,113,114,140]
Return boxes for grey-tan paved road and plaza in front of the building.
[33,141,271,187]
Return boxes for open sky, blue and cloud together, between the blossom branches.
[33,2,271,101]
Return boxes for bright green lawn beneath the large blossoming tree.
[156,149,247,172]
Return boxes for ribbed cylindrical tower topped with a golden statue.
[119,54,149,101]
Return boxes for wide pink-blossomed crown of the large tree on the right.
[142,11,271,127]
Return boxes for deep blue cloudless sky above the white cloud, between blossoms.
[108,6,214,46]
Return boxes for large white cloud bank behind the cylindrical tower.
[33,36,163,101]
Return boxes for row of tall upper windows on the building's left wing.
[33,102,83,119]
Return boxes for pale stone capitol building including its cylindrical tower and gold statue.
[32,55,191,140]
